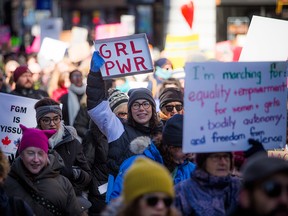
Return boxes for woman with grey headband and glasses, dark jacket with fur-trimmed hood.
[34,98,91,196]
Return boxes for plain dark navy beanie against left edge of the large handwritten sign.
[162,114,183,147]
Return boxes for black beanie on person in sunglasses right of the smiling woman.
[159,88,183,109]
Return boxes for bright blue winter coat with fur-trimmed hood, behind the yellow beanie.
[107,137,195,202]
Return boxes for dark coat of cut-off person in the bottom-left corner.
[0,186,34,216]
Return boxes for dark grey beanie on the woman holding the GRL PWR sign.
[128,88,156,110]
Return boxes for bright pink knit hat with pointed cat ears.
[18,124,56,154]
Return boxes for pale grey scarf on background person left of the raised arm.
[68,84,86,126]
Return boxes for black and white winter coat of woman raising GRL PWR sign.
[86,72,160,176]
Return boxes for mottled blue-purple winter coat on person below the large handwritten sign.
[175,169,240,216]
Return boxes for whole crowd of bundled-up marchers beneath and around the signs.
[0,45,288,216]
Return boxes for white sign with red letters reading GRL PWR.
[95,34,154,79]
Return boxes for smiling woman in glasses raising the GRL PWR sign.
[86,52,160,176]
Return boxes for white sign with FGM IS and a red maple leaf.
[0,93,38,159]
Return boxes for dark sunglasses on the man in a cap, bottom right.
[261,181,288,198]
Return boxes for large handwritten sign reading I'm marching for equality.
[183,62,287,152]
